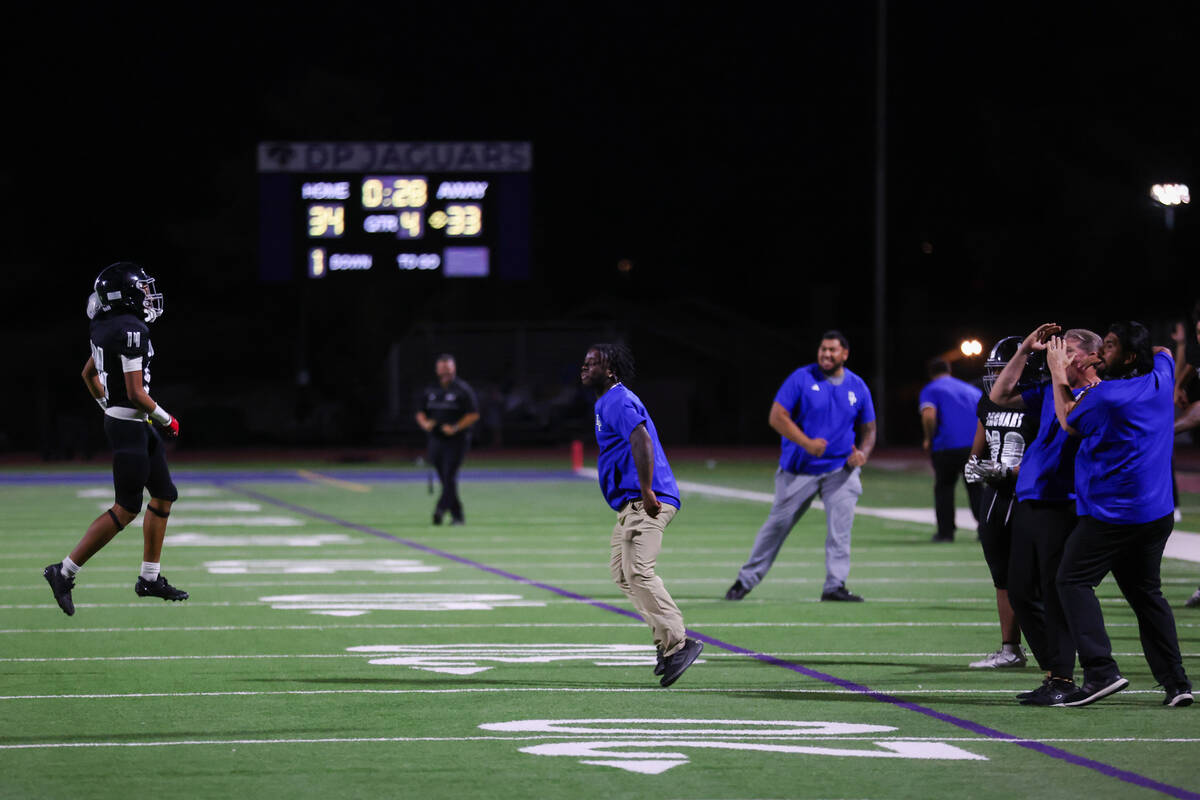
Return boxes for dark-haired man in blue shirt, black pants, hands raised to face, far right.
[1046,321,1193,706]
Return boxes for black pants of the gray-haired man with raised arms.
[1008,500,1079,678]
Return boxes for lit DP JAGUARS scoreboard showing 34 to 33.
[258,142,533,281]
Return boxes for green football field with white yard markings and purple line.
[0,457,1200,800]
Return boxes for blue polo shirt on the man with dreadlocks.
[595,384,679,511]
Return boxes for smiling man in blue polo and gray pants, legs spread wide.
[725,331,875,601]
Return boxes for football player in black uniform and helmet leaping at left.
[42,261,187,615]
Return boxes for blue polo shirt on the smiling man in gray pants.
[775,363,875,475]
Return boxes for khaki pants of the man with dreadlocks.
[608,500,685,656]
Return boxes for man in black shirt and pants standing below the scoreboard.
[416,353,479,525]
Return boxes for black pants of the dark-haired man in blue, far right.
[1058,513,1187,685]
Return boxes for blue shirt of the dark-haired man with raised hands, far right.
[1067,353,1175,525]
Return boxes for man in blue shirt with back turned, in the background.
[917,359,983,542]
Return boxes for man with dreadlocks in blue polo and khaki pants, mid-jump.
[580,344,704,686]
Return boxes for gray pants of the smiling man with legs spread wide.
[738,467,863,593]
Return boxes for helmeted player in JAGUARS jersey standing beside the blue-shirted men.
[962,336,1045,668]
